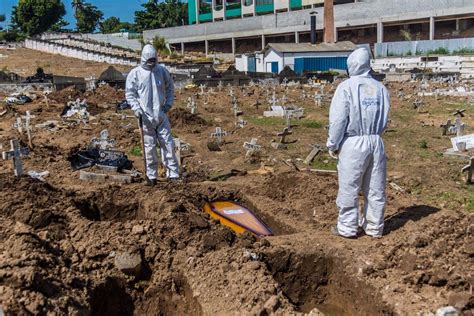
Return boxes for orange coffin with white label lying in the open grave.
[204,201,273,236]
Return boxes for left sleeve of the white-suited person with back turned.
[326,86,350,152]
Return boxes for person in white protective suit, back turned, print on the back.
[327,48,390,238]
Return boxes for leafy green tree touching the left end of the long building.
[135,0,188,31]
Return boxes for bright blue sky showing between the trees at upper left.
[0,0,148,28]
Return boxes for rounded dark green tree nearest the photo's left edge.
[12,0,66,36]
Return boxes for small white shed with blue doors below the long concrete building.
[235,42,357,74]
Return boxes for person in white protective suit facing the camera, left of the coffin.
[125,45,179,185]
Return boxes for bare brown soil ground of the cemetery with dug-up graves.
[0,53,474,315]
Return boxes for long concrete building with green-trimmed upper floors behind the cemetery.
[143,0,474,54]
